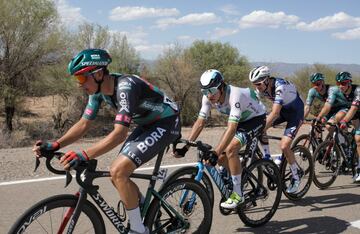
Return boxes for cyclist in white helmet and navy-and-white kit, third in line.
[249,66,304,193]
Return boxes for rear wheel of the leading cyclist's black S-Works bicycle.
[144,178,212,234]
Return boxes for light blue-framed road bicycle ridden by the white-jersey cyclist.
[163,138,282,227]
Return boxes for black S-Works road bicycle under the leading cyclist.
[9,147,212,234]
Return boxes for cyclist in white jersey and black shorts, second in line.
[174,69,266,209]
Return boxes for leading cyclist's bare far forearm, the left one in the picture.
[57,117,92,147]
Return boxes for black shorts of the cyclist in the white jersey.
[235,114,266,146]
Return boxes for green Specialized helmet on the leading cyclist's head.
[68,49,112,75]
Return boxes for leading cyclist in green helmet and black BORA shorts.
[33,49,180,233]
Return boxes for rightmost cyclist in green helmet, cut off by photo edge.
[324,72,360,182]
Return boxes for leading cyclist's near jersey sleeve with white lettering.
[115,78,141,127]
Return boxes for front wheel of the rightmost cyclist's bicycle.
[313,140,341,189]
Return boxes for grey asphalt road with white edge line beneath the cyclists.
[0,128,360,234]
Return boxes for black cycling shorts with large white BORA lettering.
[120,115,181,167]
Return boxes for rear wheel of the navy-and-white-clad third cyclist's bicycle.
[280,145,314,201]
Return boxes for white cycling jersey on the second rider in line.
[199,85,266,123]
